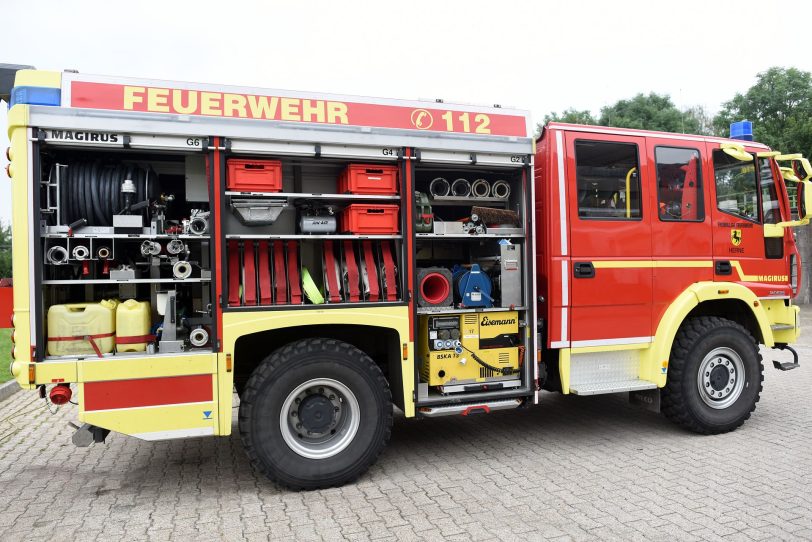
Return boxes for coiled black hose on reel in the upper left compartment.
[60,160,152,226]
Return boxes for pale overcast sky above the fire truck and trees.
[0,0,812,225]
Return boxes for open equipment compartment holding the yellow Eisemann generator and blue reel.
[413,159,532,404]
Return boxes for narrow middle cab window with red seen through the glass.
[654,147,705,222]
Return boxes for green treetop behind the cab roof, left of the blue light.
[598,92,702,134]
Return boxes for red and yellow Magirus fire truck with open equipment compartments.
[0,65,812,489]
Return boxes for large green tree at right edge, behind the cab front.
[713,67,812,156]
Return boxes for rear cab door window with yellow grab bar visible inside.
[575,141,642,220]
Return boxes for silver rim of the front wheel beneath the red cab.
[697,347,746,409]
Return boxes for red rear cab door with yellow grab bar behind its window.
[566,132,652,347]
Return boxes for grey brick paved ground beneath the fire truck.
[0,313,812,542]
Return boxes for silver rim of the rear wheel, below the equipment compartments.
[279,378,360,459]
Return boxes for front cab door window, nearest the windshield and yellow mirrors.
[713,149,759,222]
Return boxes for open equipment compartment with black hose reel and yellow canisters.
[35,149,215,357]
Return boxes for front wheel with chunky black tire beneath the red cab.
[662,316,764,435]
